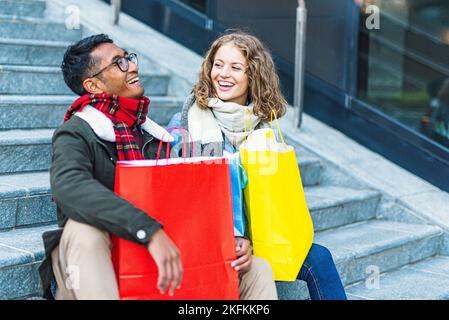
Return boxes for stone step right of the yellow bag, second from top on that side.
[304,186,380,232]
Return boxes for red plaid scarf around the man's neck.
[64,93,150,160]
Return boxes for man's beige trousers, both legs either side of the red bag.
[52,219,277,300]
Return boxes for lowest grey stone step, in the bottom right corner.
[347,256,449,300]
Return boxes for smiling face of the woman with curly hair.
[210,43,249,105]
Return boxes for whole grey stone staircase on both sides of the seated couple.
[0,0,449,299]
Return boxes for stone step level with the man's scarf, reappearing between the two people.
[0,95,183,130]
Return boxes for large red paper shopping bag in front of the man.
[112,131,239,300]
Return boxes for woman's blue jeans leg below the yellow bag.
[297,243,347,300]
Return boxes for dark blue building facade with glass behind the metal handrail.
[107,0,449,191]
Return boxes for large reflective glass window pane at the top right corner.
[356,0,449,147]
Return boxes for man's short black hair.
[61,34,114,96]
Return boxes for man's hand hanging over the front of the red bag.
[148,229,183,296]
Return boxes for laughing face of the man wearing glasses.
[83,43,145,99]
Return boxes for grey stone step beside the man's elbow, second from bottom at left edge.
[0,172,56,231]
